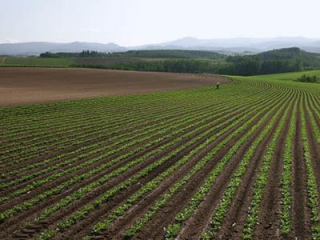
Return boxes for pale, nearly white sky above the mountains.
[0,0,320,46]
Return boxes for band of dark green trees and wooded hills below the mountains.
[40,48,320,76]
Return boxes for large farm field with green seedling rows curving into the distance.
[0,70,320,239]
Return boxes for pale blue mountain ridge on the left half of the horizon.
[0,42,127,56]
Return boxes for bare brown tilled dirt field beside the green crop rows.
[0,68,229,106]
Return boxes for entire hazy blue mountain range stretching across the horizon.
[0,37,320,56]
